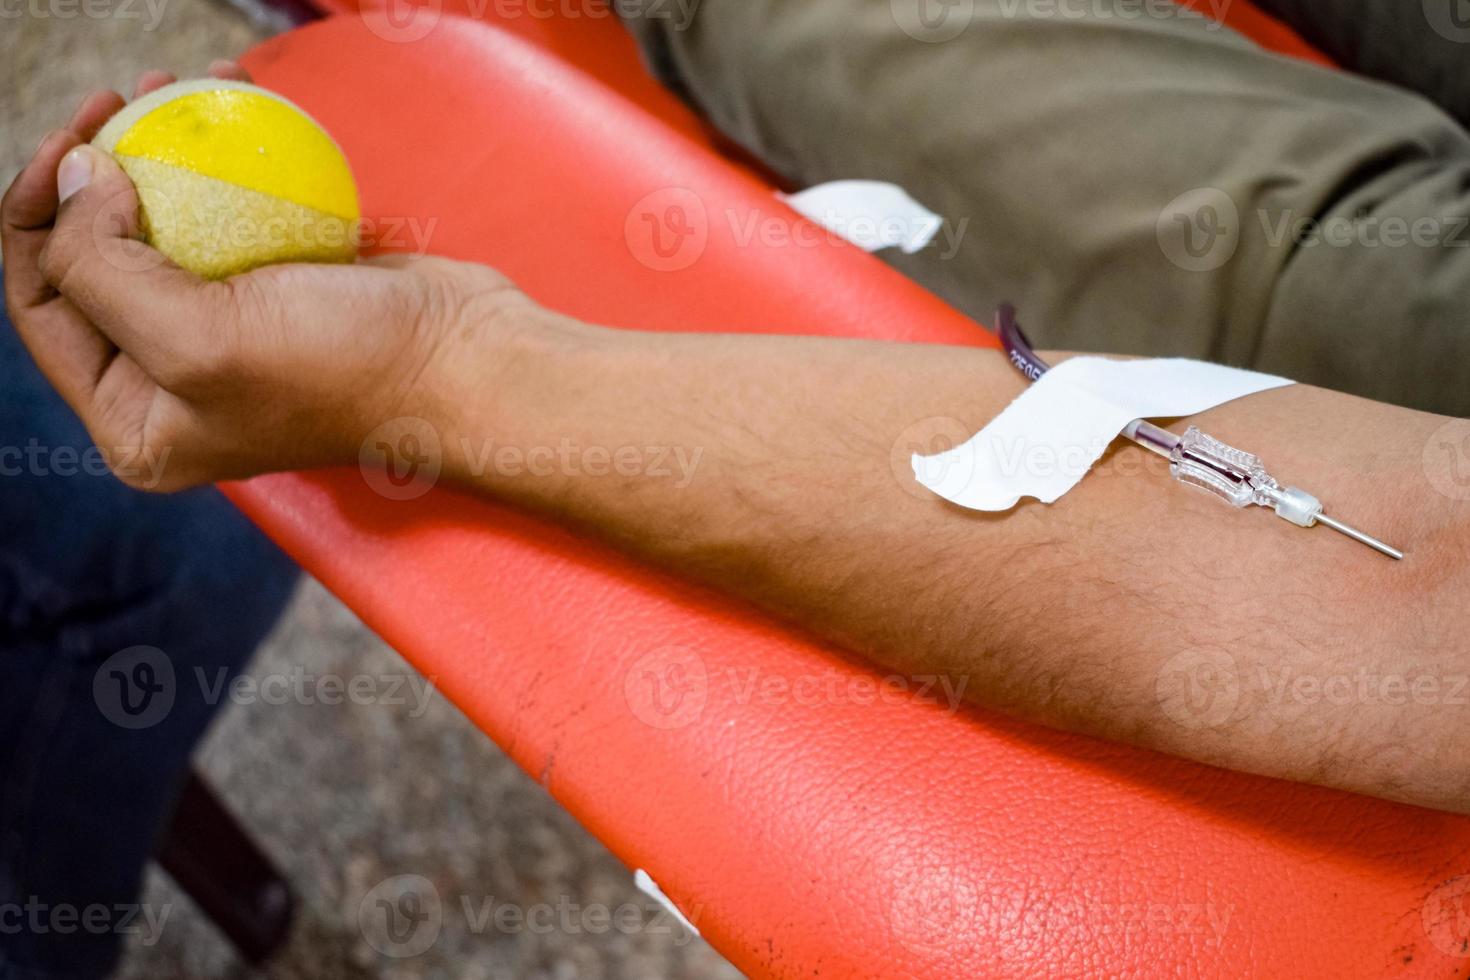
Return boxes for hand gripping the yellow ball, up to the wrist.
[0,62,535,491]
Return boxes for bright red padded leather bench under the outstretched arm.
[226,0,1470,980]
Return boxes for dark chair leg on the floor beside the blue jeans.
[157,773,295,964]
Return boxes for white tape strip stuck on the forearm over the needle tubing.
[913,357,1292,510]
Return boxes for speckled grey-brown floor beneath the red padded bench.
[0,7,739,980]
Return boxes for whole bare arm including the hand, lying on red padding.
[11,78,1470,813]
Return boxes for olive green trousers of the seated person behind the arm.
[619,0,1470,416]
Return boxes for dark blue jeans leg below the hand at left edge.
[0,287,297,980]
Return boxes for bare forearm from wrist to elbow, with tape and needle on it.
[435,314,1470,811]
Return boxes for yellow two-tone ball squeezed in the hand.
[93,79,359,279]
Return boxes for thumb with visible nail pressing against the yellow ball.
[40,145,221,381]
